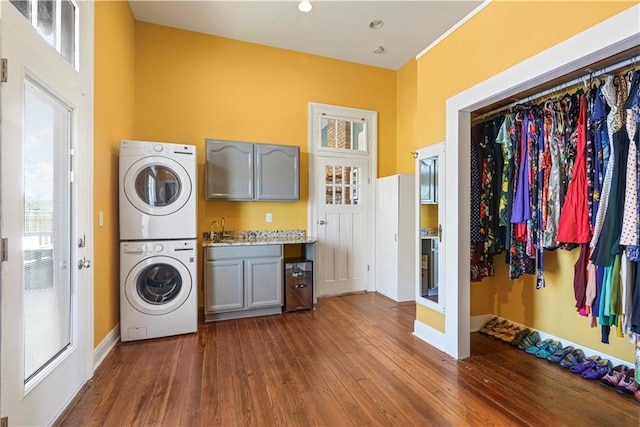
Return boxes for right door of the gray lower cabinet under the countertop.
[245,258,282,308]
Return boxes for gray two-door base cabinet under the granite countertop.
[204,245,283,321]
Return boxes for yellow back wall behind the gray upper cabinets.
[135,22,396,314]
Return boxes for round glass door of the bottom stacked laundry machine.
[124,256,192,316]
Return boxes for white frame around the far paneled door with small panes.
[307,102,378,301]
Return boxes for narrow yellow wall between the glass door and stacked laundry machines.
[93,1,135,346]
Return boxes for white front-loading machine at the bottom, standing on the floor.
[120,240,198,341]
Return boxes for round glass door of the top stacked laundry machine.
[123,156,193,216]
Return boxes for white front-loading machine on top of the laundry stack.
[120,141,197,240]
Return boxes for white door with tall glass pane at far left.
[0,0,93,425]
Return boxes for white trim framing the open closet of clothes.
[436,5,640,359]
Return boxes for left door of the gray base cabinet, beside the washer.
[204,259,244,313]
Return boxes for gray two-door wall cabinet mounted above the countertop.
[205,139,300,201]
